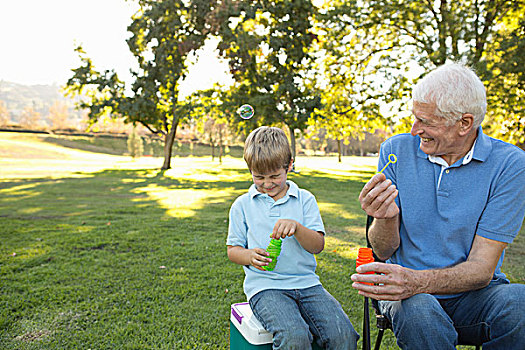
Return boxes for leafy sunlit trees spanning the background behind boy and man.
[67,0,525,169]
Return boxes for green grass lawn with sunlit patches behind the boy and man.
[0,133,525,349]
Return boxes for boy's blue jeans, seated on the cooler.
[250,285,359,350]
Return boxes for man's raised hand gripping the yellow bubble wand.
[359,173,399,219]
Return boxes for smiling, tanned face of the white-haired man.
[410,102,463,164]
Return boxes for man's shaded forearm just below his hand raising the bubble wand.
[368,215,399,260]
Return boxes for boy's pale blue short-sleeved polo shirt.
[226,180,324,300]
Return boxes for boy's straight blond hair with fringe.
[244,126,292,174]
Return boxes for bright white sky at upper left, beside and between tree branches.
[0,0,229,94]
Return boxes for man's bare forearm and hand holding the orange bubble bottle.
[352,236,507,300]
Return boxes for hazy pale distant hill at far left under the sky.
[0,80,81,123]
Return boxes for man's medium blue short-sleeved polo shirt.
[378,127,525,297]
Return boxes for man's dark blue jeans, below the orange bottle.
[379,282,525,350]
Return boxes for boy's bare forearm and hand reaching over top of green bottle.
[271,219,324,254]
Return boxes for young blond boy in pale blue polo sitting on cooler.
[226,126,359,350]
